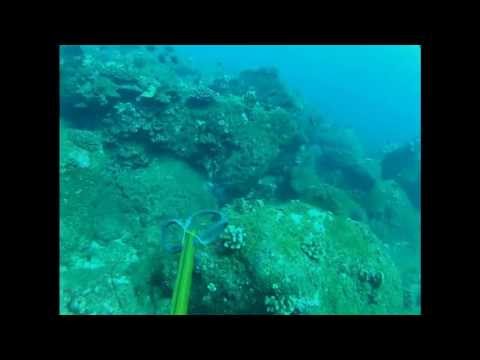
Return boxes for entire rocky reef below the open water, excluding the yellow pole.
[60,46,419,314]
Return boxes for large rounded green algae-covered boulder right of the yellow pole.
[151,200,403,314]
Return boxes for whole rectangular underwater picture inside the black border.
[59,45,421,315]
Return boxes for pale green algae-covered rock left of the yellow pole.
[60,143,215,314]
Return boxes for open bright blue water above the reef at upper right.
[175,45,420,152]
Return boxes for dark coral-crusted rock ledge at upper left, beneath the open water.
[61,45,299,194]
